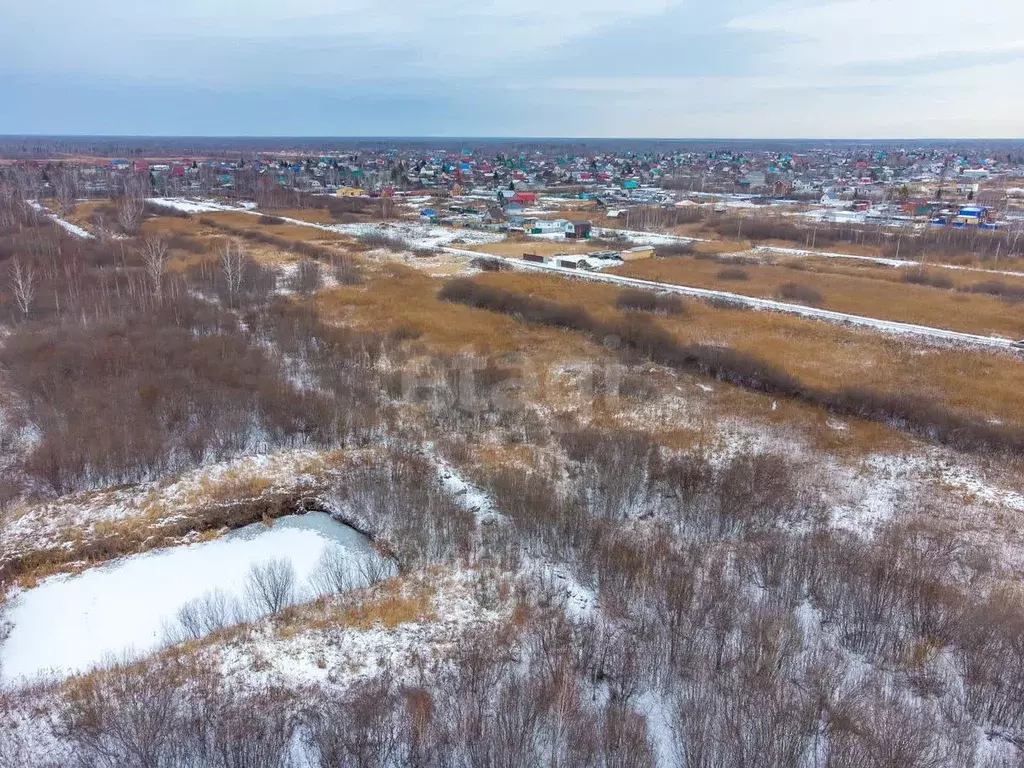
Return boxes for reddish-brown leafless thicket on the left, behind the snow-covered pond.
[0,215,386,502]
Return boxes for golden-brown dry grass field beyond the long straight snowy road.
[609,258,1024,339]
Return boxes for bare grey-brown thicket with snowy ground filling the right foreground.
[18,429,1024,768]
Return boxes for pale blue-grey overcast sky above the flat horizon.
[0,0,1024,138]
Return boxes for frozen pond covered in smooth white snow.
[0,512,385,683]
